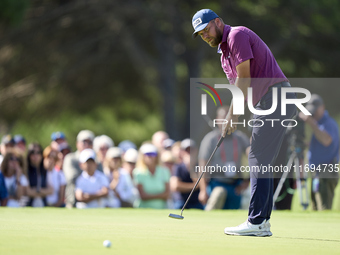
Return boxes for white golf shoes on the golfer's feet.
[224,220,273,236]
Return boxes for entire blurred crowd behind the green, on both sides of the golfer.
[0,98,339,210]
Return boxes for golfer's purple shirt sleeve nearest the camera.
[229,30,254,66]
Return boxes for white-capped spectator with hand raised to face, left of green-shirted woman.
[104,147,135,207]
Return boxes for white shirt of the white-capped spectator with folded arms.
[76,170,109,208]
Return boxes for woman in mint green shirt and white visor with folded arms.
[133,143,170,209]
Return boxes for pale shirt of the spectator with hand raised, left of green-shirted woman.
[105,168,135,207]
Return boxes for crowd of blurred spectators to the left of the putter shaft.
[0,126,250,209]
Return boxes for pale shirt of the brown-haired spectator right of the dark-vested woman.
[46,168,66,205]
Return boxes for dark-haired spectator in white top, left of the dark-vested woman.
[1,151,28,207]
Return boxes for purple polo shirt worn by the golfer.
[218,25,288,106]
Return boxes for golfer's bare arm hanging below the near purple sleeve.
[222,59,250,137]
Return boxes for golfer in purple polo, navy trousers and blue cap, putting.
[192,9,296,236]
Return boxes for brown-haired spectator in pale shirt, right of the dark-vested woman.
[43,146,66,207]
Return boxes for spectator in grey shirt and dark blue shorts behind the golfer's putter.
[199,106,250,210]
